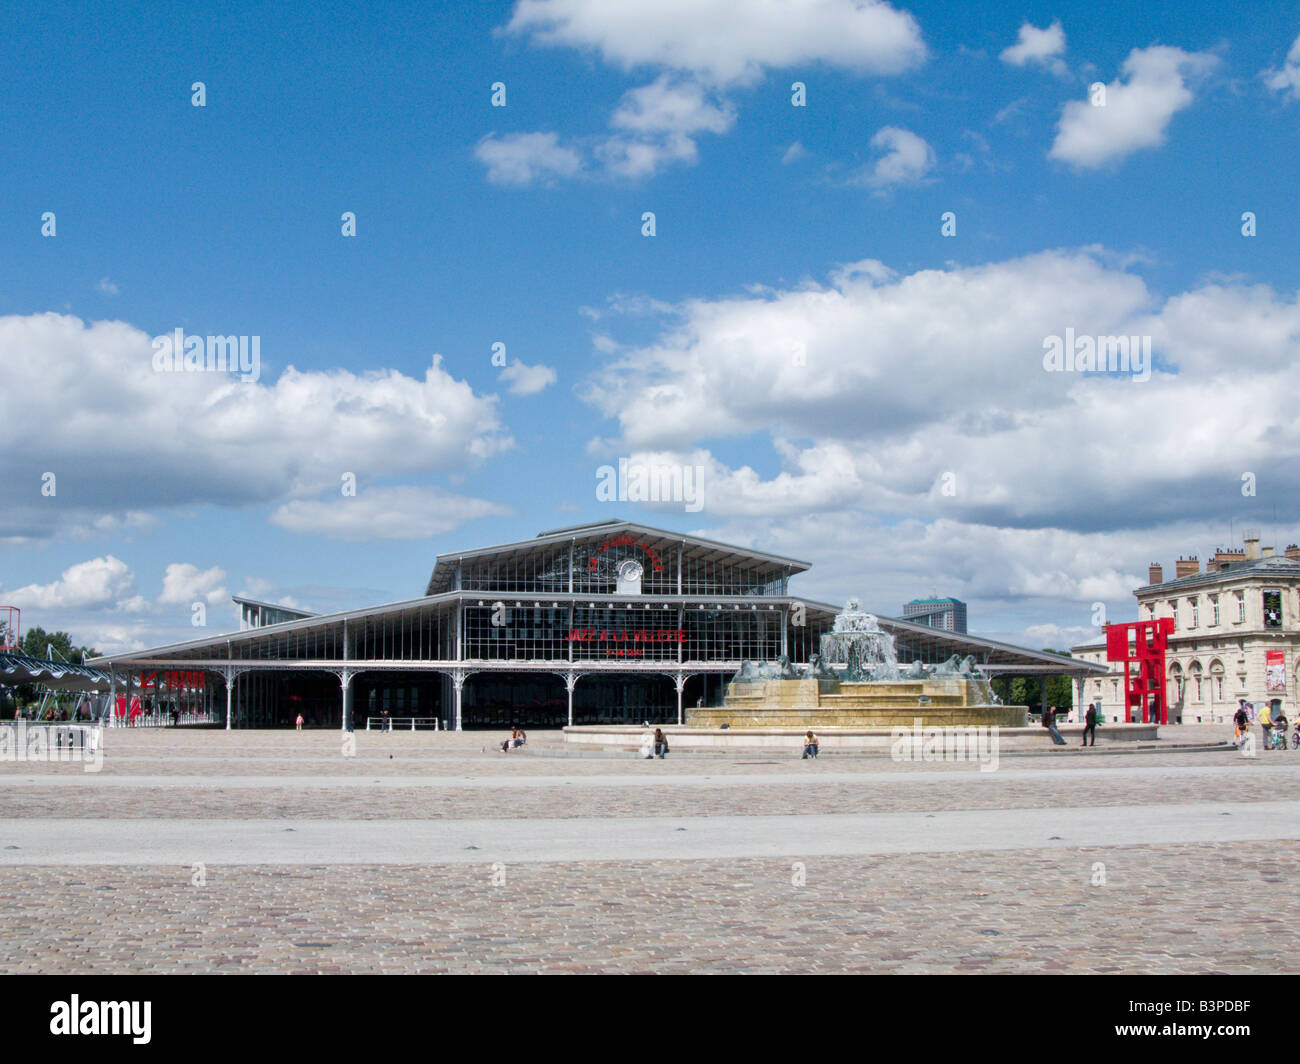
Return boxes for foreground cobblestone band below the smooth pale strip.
[0,843,1300,973]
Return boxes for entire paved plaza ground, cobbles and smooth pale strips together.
[0,728,1300,973]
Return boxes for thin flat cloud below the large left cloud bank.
[270,486,511,541]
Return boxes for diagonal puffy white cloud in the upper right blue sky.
[1048,46,1218,168]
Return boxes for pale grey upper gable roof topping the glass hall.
[424,520,811,594]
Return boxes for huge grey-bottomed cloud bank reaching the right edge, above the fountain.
[580,250,1300,533]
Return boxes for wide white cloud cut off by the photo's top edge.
[507,0,926,85]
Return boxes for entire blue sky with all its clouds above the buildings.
[0,0,1300,649]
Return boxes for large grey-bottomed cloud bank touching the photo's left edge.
[0,313,512,539]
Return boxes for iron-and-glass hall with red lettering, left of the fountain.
[94,523,1086,728]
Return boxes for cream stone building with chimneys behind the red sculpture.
[1071,533,1300,725]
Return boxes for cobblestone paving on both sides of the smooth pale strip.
[0,730,1300,973]
